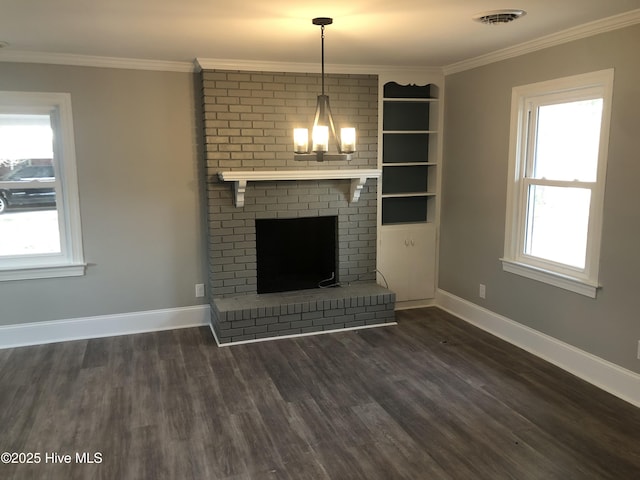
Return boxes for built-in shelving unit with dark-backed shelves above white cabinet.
[377,77,443,308]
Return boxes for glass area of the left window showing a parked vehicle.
[0,114,61,256]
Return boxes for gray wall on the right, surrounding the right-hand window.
[439,25,640,372]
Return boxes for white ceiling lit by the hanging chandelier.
[0,0,640,67]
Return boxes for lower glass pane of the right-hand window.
[525,185,591,269]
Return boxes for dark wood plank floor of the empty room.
[0,308,640,480]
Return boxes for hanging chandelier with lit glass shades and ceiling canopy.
[293,17,356,162]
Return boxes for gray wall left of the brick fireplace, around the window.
[0,62,206,325]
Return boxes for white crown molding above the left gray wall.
[0,50,194,72]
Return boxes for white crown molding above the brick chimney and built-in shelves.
[194,57,442,75]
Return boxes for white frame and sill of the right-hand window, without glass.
[501,69,613,298]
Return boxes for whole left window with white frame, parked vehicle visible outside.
[0,92,85,280]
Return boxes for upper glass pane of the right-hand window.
[533,98,602,182]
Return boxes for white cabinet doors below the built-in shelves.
[378,223,436,302]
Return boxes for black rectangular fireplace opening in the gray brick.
[256,216,338,293]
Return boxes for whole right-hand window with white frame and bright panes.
[502,70,613,298]
